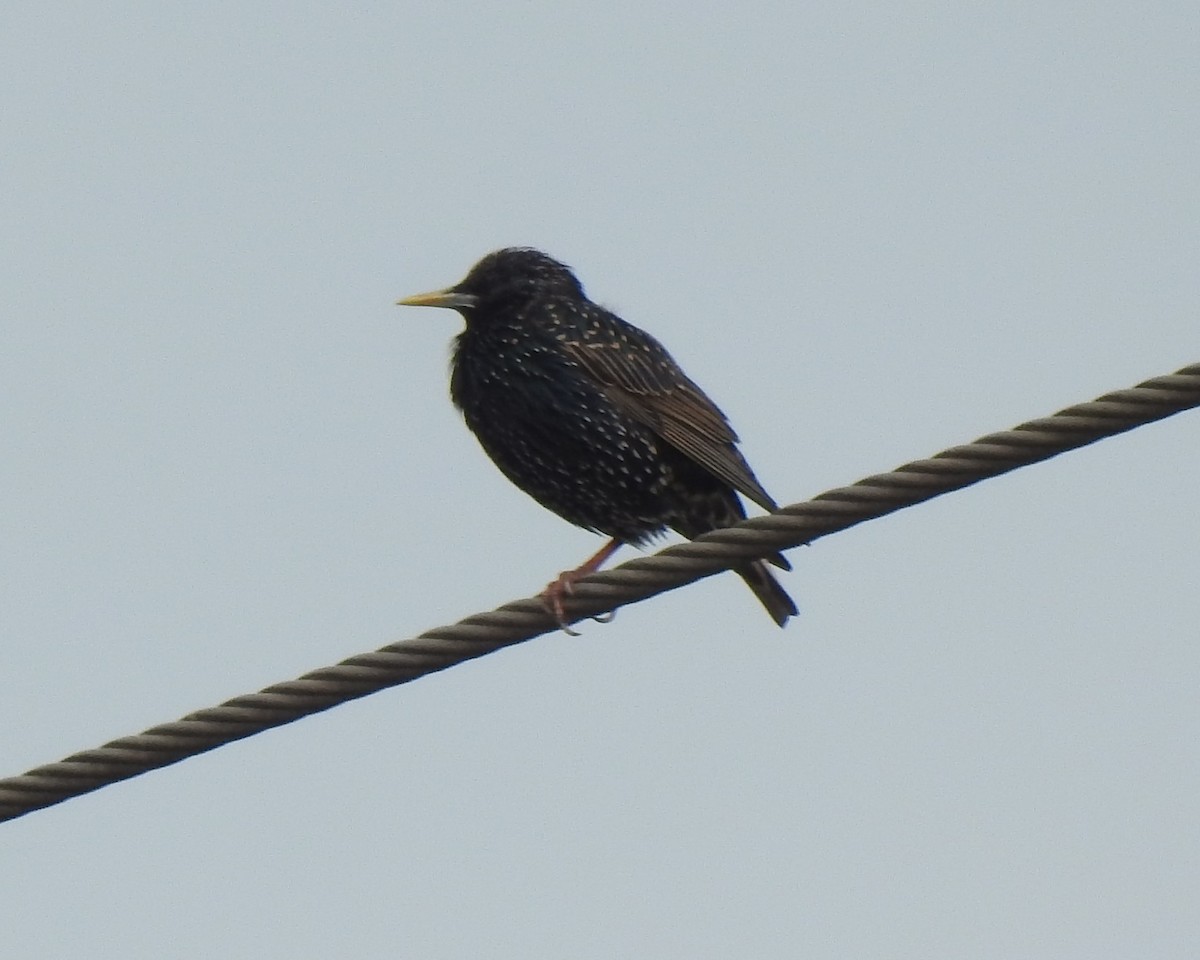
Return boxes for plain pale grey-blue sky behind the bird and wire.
[0,0,1200,960]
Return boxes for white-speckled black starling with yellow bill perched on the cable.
[398,247,797,628]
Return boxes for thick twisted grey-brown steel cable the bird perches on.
[0,364,1200,821]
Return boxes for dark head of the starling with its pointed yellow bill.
[396,247,584,323]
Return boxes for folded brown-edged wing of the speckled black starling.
[563,323,776,510]
